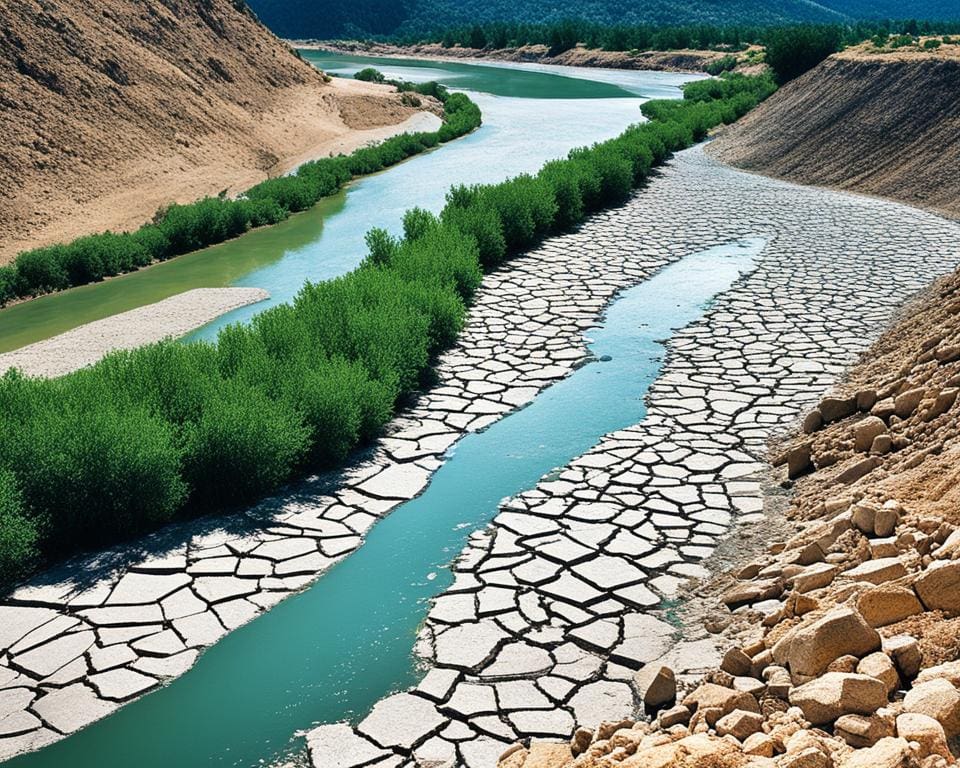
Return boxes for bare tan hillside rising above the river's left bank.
[0,0,432,263]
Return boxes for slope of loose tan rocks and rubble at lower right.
[500,254,960,768]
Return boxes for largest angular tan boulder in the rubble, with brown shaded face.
[774,607,880,677]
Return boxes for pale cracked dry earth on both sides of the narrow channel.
[0,147,960,768]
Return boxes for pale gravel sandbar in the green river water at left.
[0,288,270,378]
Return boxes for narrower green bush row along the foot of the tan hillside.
[0,82,481,306]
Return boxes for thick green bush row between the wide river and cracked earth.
[0,70,772,581]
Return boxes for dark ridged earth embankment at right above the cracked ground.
[711,45,960,216]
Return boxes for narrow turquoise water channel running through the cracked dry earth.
[1,239,763,768]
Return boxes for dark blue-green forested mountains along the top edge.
[248,0,960,38]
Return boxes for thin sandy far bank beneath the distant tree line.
[289,40,757,74]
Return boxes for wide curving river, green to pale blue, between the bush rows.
[0,52,691,352]
